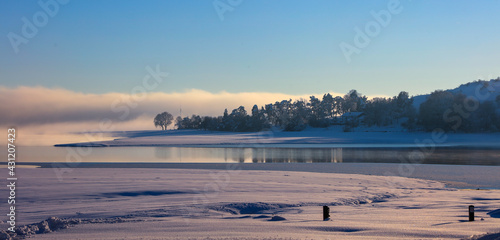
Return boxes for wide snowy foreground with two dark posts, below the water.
[0,168,500,239]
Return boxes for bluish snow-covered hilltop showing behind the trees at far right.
[413,77,500,111]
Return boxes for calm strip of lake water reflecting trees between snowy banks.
[10,146,500,165]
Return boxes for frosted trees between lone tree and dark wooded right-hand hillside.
[176,90,416,132]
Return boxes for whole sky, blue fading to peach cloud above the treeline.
[0,0,500,140]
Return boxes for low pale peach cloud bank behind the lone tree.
[0,87,336,131]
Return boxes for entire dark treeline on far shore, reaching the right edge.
[175,82,500,132]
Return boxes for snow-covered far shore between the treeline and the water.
[54,126,500,147]
